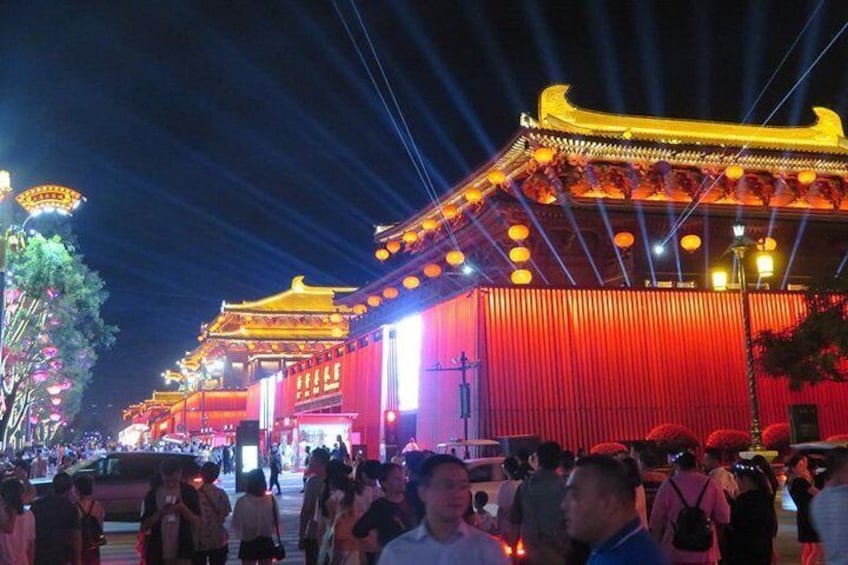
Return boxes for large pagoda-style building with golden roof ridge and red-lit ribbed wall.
[278,85,848,456]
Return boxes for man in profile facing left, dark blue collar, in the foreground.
[563,455,669,565]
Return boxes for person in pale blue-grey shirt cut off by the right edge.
[810,447,848,565]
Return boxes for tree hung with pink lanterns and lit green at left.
[0,235,117,444]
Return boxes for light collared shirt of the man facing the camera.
[379,520,510,565]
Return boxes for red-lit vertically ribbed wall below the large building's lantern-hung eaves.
[480,288,848,448]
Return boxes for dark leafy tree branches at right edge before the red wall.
[754,279,848,390]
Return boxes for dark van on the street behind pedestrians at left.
[32,452,201,522]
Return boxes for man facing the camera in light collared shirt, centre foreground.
[379,455,509,565]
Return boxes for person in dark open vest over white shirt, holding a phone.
[141,459,201,565]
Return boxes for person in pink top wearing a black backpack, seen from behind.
[649,451,730,565]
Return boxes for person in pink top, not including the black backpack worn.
[650,452,730,565]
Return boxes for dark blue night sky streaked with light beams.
[0,0,848,431]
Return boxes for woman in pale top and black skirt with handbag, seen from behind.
[232,469,285,565]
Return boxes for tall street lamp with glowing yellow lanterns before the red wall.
[712,223,774,451]
